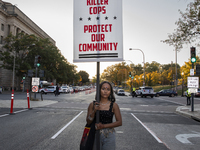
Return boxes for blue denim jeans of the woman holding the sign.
[93,129,115,150]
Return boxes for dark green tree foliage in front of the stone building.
[0,33,79,84]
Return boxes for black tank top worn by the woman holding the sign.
[99,102,114,124]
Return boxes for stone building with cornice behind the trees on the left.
[0,0,55,89]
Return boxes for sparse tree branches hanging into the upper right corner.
[162,0,200,50]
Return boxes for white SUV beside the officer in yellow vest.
[135,86,155,98]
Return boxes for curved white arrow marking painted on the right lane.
[176,134,200,145]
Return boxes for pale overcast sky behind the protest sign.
[4,0,195,78]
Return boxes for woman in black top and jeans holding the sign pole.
[86,81,122,150]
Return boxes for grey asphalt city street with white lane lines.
[0,92,200,150]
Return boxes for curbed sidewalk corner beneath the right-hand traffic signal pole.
[176,104,200,121]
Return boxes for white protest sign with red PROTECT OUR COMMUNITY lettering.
[73,0,123,62]
